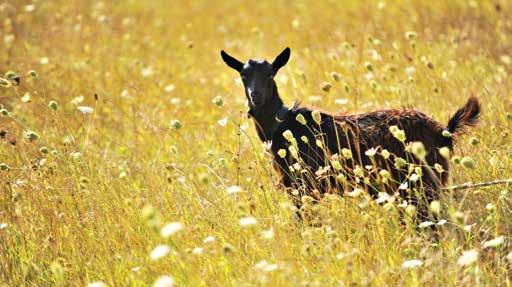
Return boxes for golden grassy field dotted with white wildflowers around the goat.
[0,0,512,286]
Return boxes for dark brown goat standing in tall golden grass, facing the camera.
[221,48,480,217]
